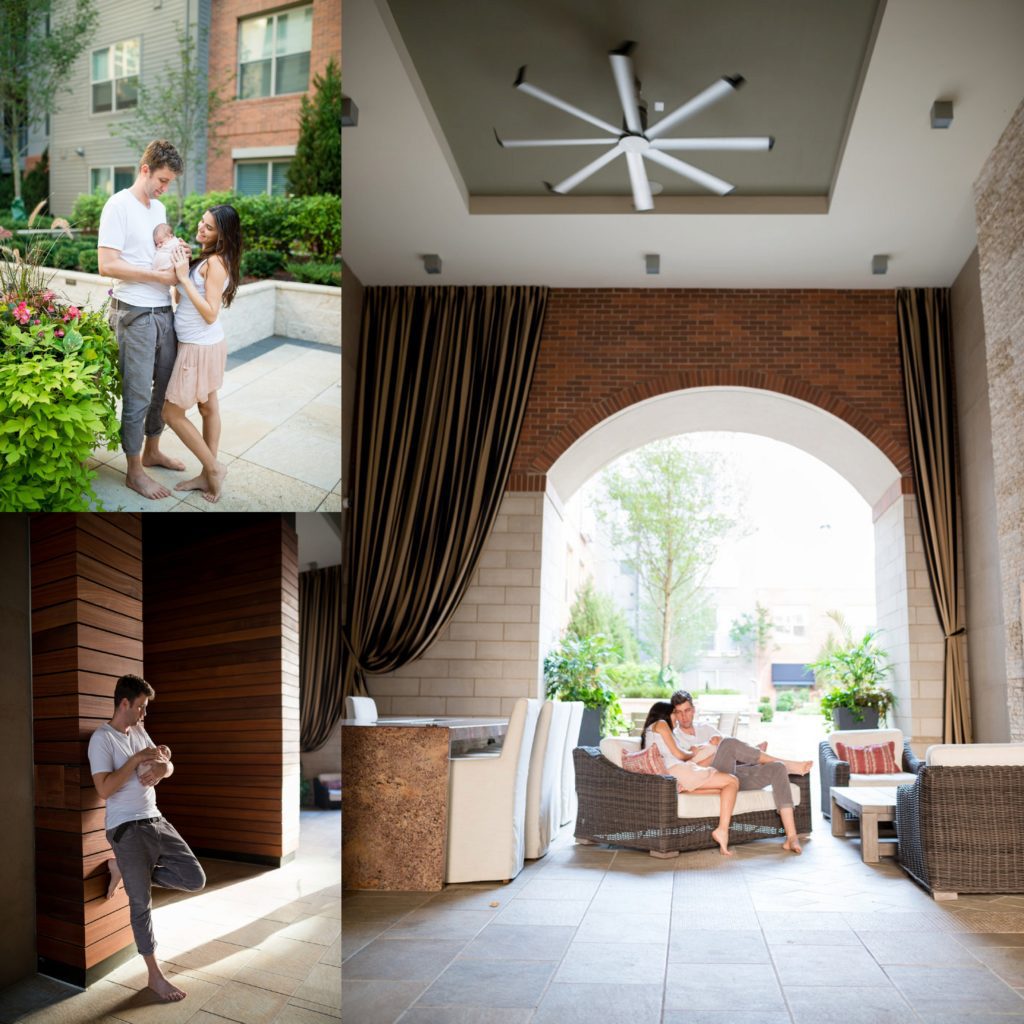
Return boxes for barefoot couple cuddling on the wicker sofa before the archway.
[640,690,812,857]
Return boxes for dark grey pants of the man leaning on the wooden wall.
[106,818,206,956]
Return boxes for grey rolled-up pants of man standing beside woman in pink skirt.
[110,306,178,455]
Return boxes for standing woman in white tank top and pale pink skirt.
[164,204,242,502]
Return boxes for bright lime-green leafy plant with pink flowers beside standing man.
[0,305,121,512]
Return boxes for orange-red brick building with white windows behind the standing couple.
[206,0,341,193]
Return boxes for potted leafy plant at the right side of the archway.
[807,611,896,729]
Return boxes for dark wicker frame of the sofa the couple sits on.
[572,746,811,854]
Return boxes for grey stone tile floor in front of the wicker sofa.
[342,720,1024,1024]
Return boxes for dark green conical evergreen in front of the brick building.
[288,57,341,196]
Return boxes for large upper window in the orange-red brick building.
[239,5,313,99]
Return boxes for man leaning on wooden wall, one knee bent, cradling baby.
[89,675,206,1002]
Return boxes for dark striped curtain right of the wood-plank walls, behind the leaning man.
[299,565,341,752]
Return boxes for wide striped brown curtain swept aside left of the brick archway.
[342,287,547,696]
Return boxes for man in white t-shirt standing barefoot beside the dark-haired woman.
[97,139,185,500]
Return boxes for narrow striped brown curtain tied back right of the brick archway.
[896,288,972,743]
